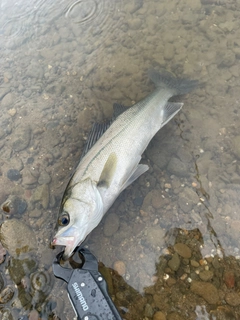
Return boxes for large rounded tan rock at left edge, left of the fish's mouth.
[0,219,37,257]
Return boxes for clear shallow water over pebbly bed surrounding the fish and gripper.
[0,0,240,320]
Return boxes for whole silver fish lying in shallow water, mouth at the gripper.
[52,69,198,260]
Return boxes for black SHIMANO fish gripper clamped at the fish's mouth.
[53,248,122,320]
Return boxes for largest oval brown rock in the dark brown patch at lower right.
[190,280,219,304]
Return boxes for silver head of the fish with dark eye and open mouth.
[52,179,103,260]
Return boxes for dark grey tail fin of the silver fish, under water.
[148,70,198,95]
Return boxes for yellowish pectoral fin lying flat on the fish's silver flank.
[97,152,117,188]
